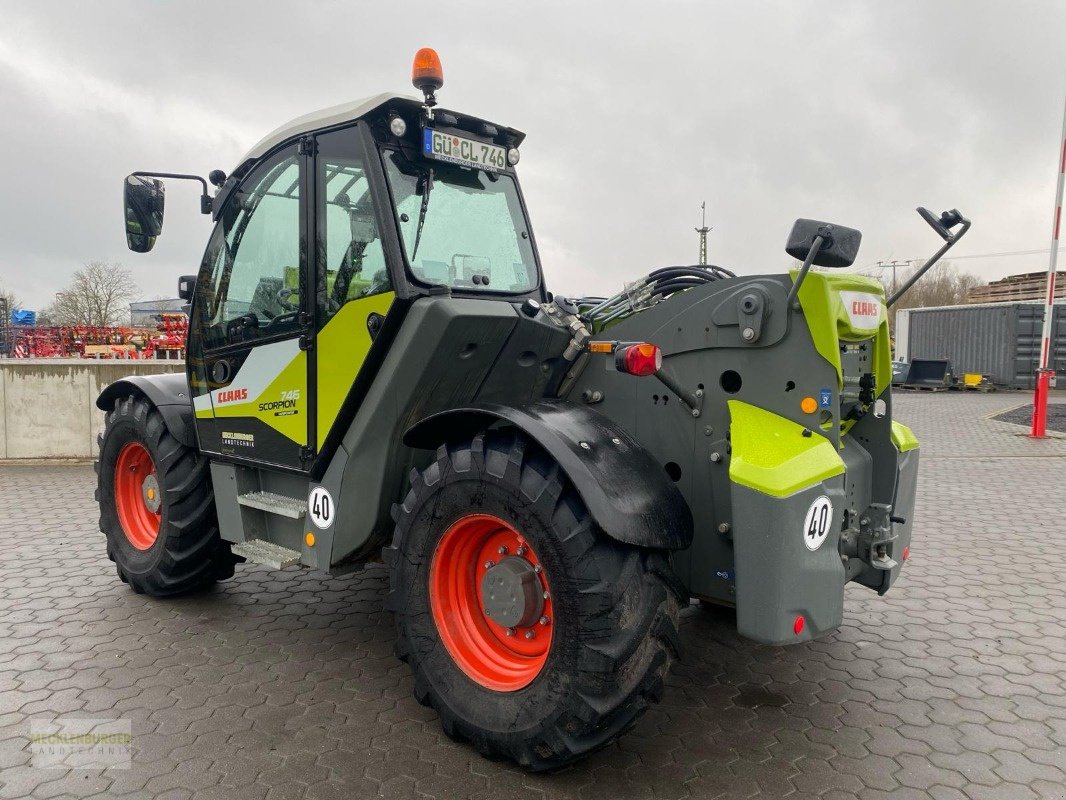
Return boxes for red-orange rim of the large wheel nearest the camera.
[430,514,555,691]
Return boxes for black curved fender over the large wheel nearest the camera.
[403,401,693,550]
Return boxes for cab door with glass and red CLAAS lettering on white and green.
[190,144,311,470]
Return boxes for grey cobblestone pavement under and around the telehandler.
[0,394,1066,800]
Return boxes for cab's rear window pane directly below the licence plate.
[385,150,537,292]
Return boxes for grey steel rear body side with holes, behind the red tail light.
[567,275,838,603]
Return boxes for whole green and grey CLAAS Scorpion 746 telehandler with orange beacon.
[103,49,970,769]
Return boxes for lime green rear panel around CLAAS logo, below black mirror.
[791,271,892,396]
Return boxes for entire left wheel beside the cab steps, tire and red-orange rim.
[96,396,236,596]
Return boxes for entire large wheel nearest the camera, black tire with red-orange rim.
[385,431,680,770]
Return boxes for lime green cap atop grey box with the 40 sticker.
[729,400,844,497]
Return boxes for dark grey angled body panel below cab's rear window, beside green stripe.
[321,297,567,564]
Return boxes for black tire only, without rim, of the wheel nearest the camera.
[384,431,681,771]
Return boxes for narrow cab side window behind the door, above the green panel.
[317,148,392,323]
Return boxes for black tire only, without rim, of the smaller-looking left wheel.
[95,395,237,597]
